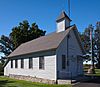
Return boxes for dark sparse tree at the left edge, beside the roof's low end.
[0,35,14,70]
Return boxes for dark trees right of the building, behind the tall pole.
[80,22,100,68]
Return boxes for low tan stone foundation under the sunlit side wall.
[9,74,56,84]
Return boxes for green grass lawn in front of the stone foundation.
[0,76,71,87]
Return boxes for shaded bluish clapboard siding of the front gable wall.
[57,31,83,78]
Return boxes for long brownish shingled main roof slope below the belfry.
[8,26,74,57]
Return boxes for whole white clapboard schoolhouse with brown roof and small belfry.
[4,12,84,83]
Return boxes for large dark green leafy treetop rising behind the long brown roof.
[10,20,46,49]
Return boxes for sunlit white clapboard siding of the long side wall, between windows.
[4,52,56,80]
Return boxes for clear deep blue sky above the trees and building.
[0,0,100,36]
